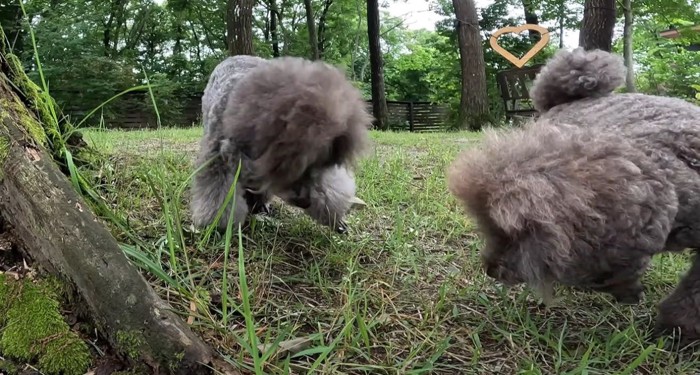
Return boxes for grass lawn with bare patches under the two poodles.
[80,128,700,374]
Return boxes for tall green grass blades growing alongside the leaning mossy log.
[10,5,268,374]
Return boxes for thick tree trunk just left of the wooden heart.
[452,0,489,130]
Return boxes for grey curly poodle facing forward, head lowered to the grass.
[191,56,372,233]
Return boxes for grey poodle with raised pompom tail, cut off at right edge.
[448,49,700,342]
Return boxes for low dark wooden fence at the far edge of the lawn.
[54,92,449,132]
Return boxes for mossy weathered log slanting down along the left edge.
[0,50,213,374]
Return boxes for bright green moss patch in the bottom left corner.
[0,275,91,375]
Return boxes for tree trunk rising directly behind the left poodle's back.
[226,0,255,56]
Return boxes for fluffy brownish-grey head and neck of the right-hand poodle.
[449,121,677,301]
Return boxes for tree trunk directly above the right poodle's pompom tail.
[578,0,615,52]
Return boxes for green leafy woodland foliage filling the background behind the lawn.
[10,0,700,126]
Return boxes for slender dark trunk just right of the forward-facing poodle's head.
[367,0,389,130]
